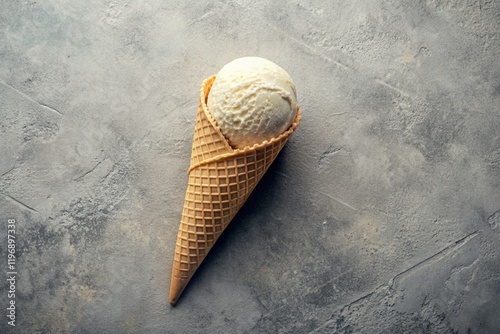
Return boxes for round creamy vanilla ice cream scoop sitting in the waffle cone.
[207,57,297,148]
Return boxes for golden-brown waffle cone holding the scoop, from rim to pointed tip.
[170,75,300,305]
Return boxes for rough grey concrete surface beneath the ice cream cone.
[0,0,500,333]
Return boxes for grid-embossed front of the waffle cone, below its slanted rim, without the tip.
[173,138,287,283]
